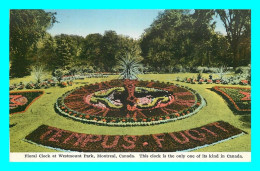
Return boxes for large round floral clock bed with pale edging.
[55,80,205,126]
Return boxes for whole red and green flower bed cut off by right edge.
[212,86,251,112]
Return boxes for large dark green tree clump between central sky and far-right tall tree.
[140,10,236,72]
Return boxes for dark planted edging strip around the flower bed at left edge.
[9,91,44,115]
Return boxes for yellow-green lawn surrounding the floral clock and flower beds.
[10,73,251,152]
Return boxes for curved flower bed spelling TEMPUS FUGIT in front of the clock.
[25,121,245,152]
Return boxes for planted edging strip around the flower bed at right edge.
[212,86,251,112]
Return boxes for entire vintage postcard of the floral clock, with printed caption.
[9,9,251,162]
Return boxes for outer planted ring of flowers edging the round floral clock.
[55,79,206,126]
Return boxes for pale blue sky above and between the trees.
[45,9,225,39]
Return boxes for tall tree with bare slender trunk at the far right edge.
[216,10,251,67]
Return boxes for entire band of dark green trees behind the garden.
[10,10,251,77]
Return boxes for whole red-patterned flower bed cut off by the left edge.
[9,91,44,114]
